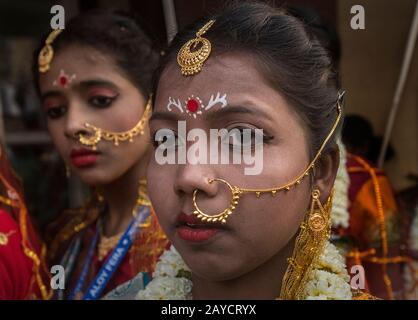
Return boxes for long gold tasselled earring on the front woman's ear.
[280,189,333,300]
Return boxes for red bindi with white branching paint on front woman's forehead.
[167,92,228,119]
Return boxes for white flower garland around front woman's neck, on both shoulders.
[136,242,352,300]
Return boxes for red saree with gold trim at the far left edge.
[0,147,52,300]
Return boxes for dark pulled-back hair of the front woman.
[154,1,341,155]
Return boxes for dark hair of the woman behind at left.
[33,9,159,97]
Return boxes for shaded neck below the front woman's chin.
[192,239,295,300]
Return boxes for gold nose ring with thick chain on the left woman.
[78,96,152,150]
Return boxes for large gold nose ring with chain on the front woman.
[192,92,345,223]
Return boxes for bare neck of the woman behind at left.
[101,151,147,237]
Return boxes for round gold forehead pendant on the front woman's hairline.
[177,20,215,76]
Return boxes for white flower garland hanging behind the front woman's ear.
[331,140,350,228]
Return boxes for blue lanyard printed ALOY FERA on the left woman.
[68,206,150,300]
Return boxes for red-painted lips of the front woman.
[177,213,223,242]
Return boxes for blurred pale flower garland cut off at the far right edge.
[404,206,418,300]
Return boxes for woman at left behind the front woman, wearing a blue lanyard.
[35,11,167,299]
